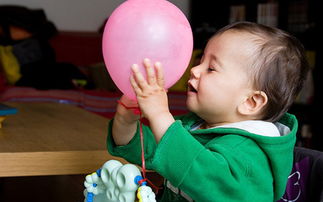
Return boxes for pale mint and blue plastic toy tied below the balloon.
[84,160,156,202]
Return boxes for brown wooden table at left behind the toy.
[0,102,125,177]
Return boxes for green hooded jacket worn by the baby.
[107,113,297,202]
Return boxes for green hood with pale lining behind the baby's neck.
[184,113,298,200]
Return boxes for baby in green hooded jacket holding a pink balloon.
[107,22,308,202]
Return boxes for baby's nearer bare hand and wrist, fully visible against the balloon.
[130,59,175,143]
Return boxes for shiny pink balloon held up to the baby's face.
[102,0,193,99]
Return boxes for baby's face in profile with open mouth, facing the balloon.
[187,31,254,125]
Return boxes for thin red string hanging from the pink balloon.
[117,100,161,194]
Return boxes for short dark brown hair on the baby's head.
[215,22,309,122]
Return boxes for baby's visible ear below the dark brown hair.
[238,91,268,117]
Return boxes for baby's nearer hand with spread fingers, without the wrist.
[130,59,169,120]
